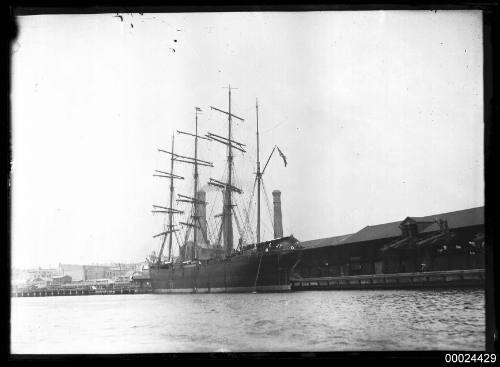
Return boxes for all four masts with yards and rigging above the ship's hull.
[153,85,286,264]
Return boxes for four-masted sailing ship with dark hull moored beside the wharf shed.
[149,86,301,293]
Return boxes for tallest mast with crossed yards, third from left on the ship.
[207,85,245,256]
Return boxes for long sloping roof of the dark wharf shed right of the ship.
[300,206,484,249]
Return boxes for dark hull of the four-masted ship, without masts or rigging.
[149,250,299,293]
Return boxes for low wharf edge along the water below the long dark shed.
[290,269,485,291]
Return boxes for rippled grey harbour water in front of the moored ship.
[11,289,485,354]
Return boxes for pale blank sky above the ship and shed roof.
[11,11,484,268]
